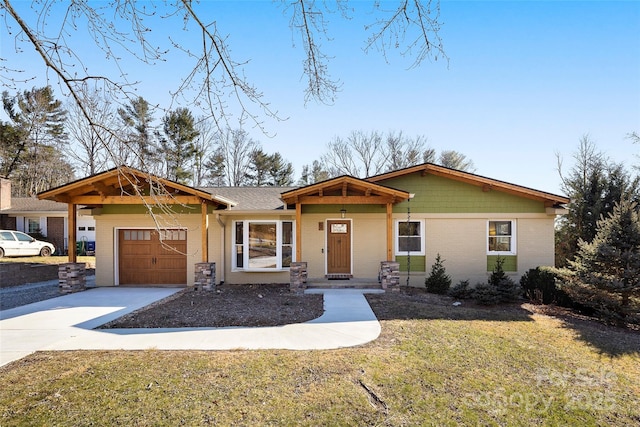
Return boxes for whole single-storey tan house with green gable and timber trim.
[39,163,569,286]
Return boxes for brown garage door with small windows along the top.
[118,229,187,285]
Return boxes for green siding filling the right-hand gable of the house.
[380,172,545,213]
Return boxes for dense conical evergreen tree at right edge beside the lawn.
[562,199,640,323]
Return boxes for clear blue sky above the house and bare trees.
[2,0,640,193]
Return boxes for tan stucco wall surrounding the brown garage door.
[95,214,215,286]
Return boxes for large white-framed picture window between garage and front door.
[232,220,295,271]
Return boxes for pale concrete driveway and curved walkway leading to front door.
[0,287,384,366]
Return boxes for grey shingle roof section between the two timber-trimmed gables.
[201,187,293,211]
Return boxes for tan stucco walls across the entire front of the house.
[96,213,554,286]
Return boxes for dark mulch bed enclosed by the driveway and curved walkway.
[101,284,324,328]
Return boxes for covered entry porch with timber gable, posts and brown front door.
[281,176,411,287]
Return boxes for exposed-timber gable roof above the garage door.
[38,166,234,207]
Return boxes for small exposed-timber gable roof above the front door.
[281,175,410,205]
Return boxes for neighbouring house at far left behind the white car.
[0,178,96,253]
